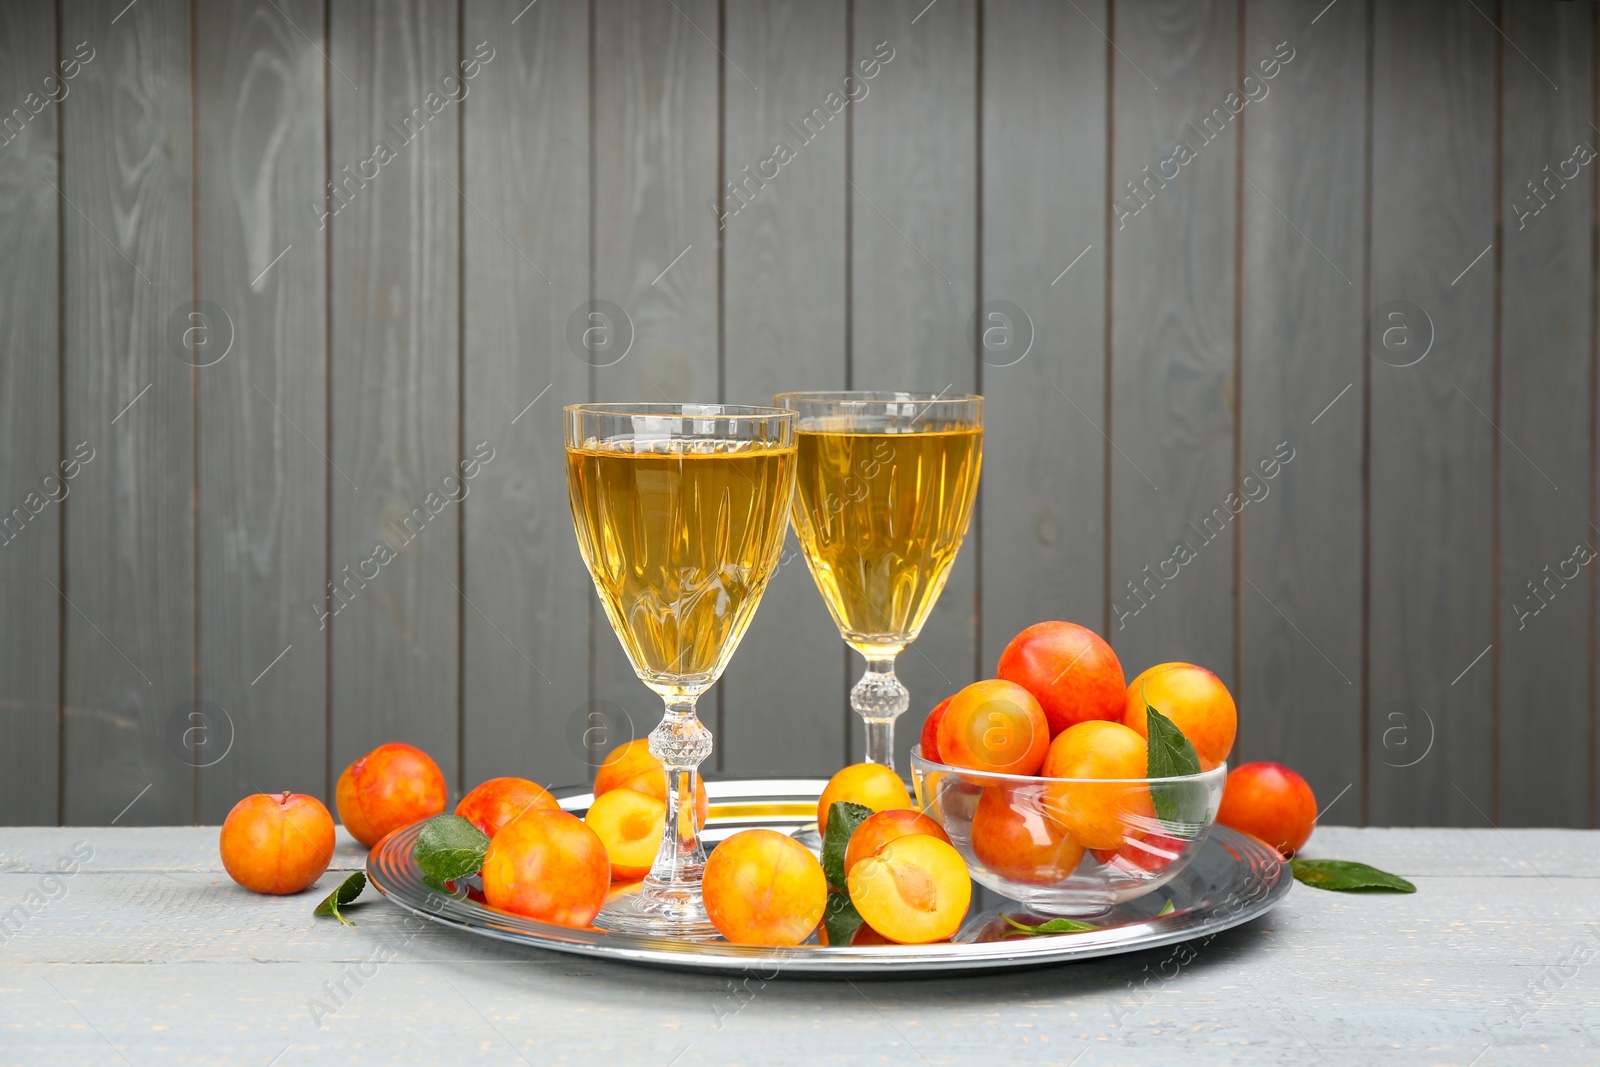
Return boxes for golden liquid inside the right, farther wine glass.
[794,427,984,656]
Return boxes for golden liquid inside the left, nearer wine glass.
[566,438,795,694]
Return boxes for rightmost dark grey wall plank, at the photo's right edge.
[1491,3,1600,825]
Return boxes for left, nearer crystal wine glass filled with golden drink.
[565,403,795,937]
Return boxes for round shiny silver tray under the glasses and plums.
[366,779,1294,977]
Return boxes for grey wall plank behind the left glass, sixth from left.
[592,0,723,771]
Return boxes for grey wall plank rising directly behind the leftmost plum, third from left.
[194,0,328,822]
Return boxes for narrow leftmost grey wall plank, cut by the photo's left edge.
[0,5,62,825]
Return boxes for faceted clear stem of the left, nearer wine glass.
[640,696,712,918]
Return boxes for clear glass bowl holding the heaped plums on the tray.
[910,745,1227,915]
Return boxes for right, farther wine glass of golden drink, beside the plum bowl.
[773,392,984,768]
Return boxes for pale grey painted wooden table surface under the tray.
[0,827,1600,1067]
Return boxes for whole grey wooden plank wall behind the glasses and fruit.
[0,0,1600,825]
